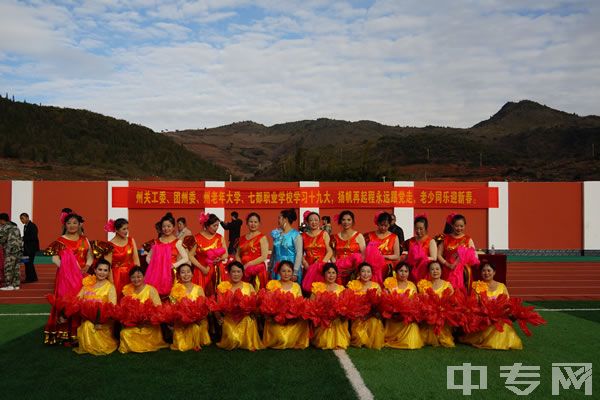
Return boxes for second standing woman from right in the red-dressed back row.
[404,214,437,283]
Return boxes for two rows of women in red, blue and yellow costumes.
[45,209,522,354]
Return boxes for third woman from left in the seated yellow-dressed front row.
[169,264,210,351]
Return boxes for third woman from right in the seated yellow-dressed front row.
[383,262,424,349]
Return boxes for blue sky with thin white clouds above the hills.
[0,0,600,130]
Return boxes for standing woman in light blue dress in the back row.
[269,208,302,284]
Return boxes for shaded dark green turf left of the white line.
[0,329,356,400]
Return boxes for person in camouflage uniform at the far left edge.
[0,213,23,290]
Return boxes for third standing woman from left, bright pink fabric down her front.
[145,213,188,298]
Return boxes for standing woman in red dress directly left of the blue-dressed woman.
[235,212,269,290]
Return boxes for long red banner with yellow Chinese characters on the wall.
[113,184,498,209]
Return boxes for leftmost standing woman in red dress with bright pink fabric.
[44,212,93,345]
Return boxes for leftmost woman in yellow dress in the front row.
[73,258,118,356]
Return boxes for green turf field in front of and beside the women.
[0,302,600,400]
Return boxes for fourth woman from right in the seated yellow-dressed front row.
[348,263,385,350]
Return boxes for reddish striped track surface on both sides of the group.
[0,262,600,304]
